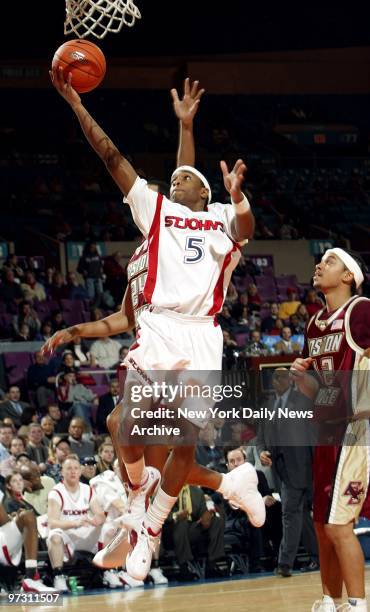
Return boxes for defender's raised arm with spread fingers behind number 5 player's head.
[171,78,205,167]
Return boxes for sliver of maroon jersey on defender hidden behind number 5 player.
[127,240,148,331]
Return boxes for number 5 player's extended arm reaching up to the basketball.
[49,67,137,195]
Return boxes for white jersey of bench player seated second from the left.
[48,482,93,529]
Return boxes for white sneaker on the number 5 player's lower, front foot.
[126,523,161,580]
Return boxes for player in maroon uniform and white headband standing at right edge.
[291,248,370,612]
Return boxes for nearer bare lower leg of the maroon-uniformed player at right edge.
[324,522,365,599]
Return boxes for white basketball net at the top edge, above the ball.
[64,0,141,38]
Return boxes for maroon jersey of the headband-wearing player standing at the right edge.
[303,296,370,420]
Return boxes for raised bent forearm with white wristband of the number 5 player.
[220,159,255,242]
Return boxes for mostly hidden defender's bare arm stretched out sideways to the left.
[41,290,134,354]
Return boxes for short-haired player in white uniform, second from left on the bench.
[47,455,105,592]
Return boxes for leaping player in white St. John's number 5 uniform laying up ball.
[51,70,265,579]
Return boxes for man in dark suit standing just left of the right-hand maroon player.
[256,368,318,577]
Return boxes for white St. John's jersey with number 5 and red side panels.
[125,177,246,316]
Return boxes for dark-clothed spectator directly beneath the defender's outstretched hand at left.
[27,351,56,413]
